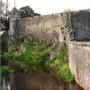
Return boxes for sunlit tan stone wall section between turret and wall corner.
[16,13,66,43]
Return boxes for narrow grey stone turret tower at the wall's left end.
[9,7,20,36]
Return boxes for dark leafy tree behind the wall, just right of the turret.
[19,6,40,18]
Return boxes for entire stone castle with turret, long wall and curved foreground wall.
[9,8,90,90]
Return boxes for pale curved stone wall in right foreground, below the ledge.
[68,42,90,90]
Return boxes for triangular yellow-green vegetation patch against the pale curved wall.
[47,47,75,83]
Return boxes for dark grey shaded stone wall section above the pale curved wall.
[70,10,90,41]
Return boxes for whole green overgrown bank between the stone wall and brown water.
[2,37,74,82]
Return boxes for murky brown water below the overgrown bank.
[11,72,83,90]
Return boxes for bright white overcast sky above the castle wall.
[2,0,90,15]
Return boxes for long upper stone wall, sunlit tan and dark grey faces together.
[12,10,90,42]
